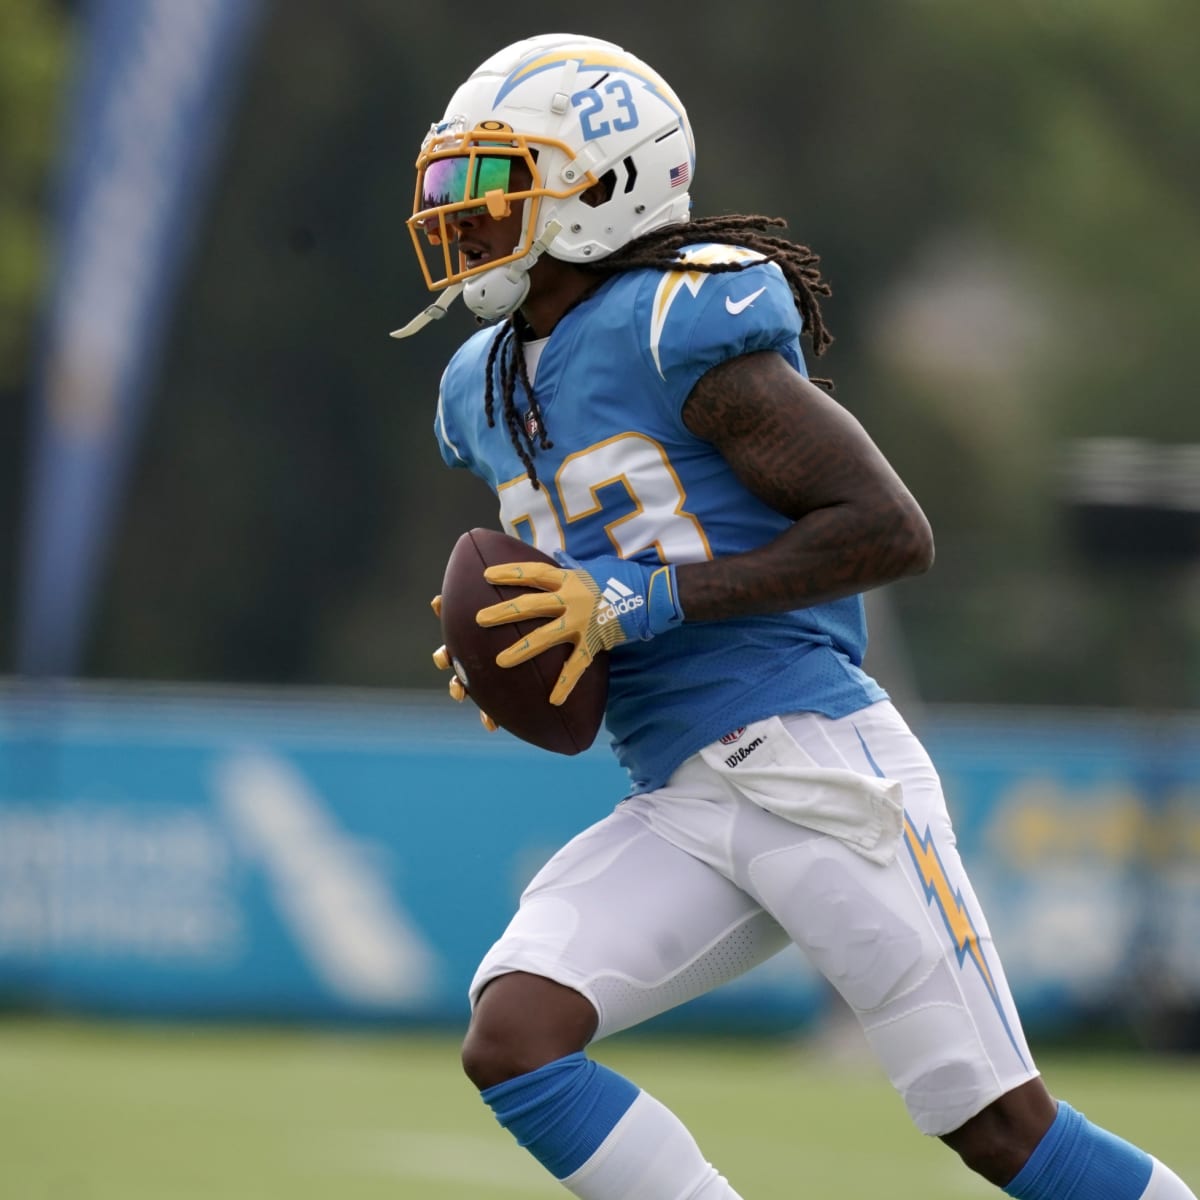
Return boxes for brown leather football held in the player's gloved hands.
[442,529,608,755]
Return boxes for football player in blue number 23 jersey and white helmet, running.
[397,35,1195,1200]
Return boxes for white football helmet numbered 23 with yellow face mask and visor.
[395,34,696,336]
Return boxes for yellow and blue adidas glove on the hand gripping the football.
[475,551,684,704]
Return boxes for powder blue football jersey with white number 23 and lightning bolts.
[436,245,884,792]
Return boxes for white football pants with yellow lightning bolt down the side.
[470,702,1037,1134]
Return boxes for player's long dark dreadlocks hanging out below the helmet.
[484,215,833,487]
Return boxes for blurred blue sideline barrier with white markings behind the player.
[0,684,1200,1032]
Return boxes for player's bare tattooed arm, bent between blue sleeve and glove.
[678,352,934,620]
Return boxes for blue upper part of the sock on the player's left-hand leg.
[480,1054,640,1180]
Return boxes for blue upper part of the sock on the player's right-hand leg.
[1004,1100,1154,1200]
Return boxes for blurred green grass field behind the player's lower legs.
[0,1020,1200,1200]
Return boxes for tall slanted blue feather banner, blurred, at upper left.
[17,0,259,676]
